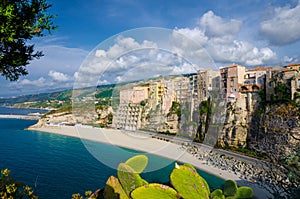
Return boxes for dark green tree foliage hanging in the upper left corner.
[0,0,56,81]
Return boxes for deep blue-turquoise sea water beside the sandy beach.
[0,107,224,199]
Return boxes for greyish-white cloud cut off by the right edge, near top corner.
[260,3,300,45]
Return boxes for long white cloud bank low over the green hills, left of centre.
[75,36,178,87]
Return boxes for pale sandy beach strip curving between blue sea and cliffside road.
[27,125,270,198]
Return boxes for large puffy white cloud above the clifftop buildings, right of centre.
[177,11,278,67]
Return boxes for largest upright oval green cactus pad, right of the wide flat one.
[170,165,210,199]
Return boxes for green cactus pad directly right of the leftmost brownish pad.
[118,163,148,196]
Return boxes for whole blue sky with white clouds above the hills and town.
[0,0,300,97]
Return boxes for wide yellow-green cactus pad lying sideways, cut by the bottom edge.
[131,183,180,199]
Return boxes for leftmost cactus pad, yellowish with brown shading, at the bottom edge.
[104,176,129,199]
